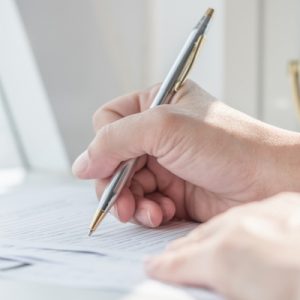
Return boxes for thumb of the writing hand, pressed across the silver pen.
[72,105,178,179]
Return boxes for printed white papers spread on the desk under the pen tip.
[0,186,220,299]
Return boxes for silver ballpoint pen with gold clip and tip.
[89,8,214,236]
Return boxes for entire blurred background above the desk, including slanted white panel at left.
[0,0,300,192]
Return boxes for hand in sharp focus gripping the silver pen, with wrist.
[73,81,300,227]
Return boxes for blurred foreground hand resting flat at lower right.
[146,193,300,300]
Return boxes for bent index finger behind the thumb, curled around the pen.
[93,84,159,132]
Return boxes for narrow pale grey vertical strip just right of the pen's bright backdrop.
[222,0,263,117]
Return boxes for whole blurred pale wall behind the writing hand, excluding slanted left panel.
[11,0,300,166]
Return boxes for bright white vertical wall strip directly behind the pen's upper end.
[148,0,224,98]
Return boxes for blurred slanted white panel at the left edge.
[0,0,69,191]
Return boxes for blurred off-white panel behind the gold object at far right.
[261,0,300,131]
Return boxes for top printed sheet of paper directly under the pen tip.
[0,188,196,256]
